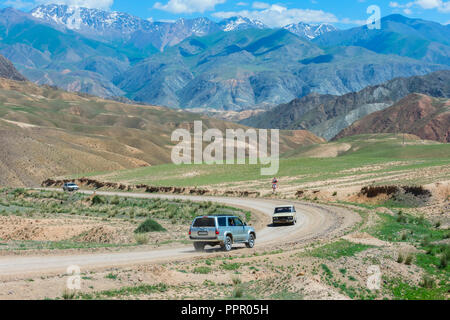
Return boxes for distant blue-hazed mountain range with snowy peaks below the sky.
[0,5,450,111]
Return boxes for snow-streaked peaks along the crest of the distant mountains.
[30,4,336,50]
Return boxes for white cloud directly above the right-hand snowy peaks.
[213,4,339,27]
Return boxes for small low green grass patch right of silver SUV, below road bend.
[307,240,374,260]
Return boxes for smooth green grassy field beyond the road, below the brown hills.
[79,134,450,187]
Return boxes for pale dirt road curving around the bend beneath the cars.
[0,191,360,277]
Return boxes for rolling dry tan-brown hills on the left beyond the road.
[0,79,323,186]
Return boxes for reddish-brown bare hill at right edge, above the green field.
[335,93,450,142]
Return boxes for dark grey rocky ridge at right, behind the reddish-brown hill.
[242,70,450,140]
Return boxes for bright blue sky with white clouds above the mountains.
[0,0,450,28]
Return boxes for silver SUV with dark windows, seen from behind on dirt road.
[189,215,256,251]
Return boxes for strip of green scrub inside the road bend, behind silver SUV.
[0,189,246,228]
